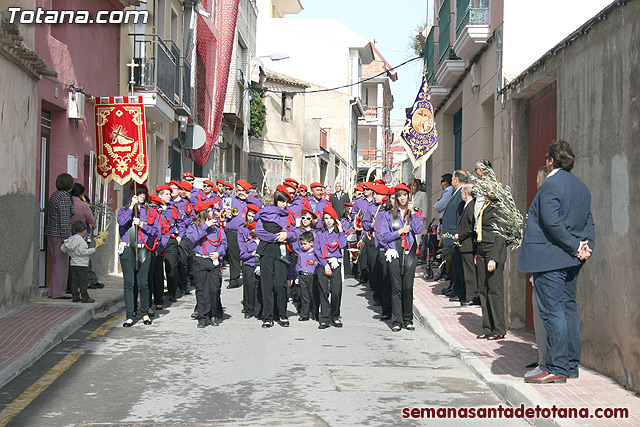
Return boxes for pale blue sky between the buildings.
[287,0,433,119]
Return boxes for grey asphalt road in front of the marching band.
[0,272,526,427]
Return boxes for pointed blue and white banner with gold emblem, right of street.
[400,74,438,168]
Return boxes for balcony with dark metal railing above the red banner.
[130,34,191,121]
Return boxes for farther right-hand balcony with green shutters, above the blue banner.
[435,0,464,88]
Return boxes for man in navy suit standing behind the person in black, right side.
[442,170,469,302]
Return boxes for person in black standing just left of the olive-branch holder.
[456,184,478,306]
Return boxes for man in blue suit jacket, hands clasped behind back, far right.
[518,140,595,383]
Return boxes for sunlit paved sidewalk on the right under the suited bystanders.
[414,269,640,426]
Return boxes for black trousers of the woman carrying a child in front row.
[260,251,287,322]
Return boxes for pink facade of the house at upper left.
[35,0,122,201]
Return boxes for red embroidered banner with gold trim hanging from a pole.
[95,96,148,185]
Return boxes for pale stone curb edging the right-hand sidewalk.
[413,299,578,427]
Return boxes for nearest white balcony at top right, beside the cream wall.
[453,0,491,61]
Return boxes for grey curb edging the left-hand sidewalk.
[0,294,124,388]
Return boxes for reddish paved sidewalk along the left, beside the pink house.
[0,275,123,388]
